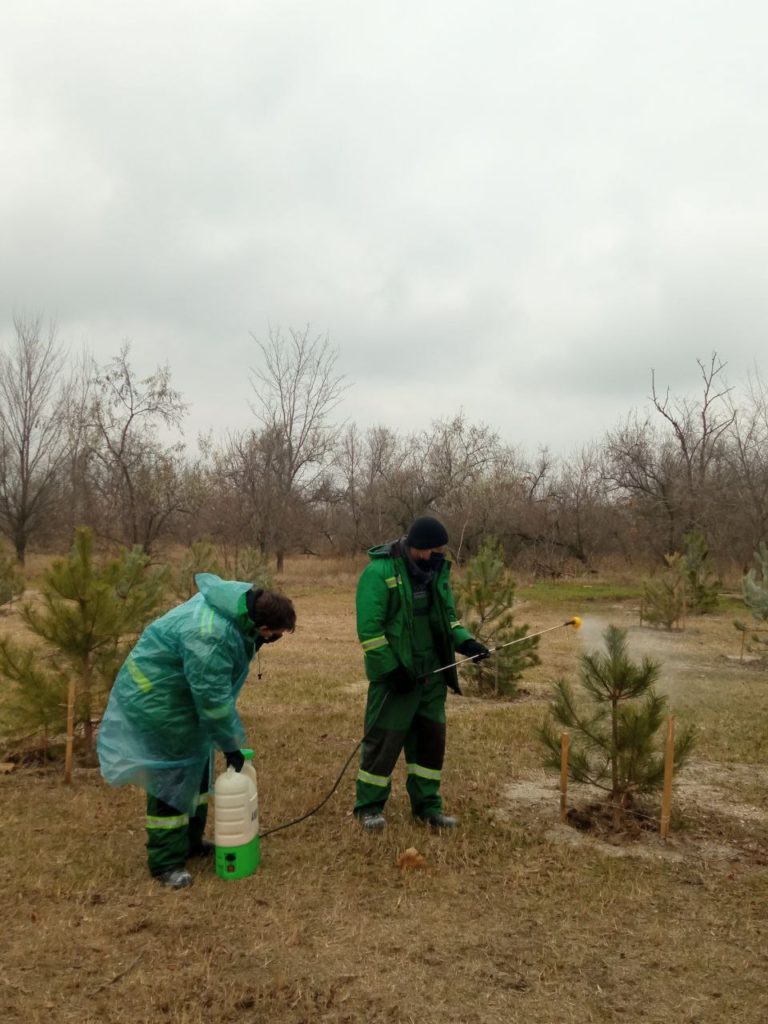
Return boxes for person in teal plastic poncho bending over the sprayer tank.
[96,572,296,889]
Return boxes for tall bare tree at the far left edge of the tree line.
[0,315,68,563]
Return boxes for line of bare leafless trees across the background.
[0,315,768,575]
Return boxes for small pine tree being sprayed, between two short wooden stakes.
[540,626,694,828]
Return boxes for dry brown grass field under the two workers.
[0,559,768,1024]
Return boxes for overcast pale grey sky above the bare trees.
[0,0,768,451]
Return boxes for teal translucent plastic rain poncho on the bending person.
[96,572,263,812]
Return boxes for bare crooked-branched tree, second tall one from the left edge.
[90,344,186,553]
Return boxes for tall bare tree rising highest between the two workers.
[251,327,347,572]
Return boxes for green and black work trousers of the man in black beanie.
[354,675,445,818]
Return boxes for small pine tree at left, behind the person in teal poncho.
[0,527,166,780]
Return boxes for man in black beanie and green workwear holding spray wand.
[354,516,490,831]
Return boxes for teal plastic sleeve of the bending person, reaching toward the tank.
[184,633,246,751]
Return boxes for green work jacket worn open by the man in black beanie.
[356,541,472,689]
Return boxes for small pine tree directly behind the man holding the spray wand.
[456,538,540,696]
